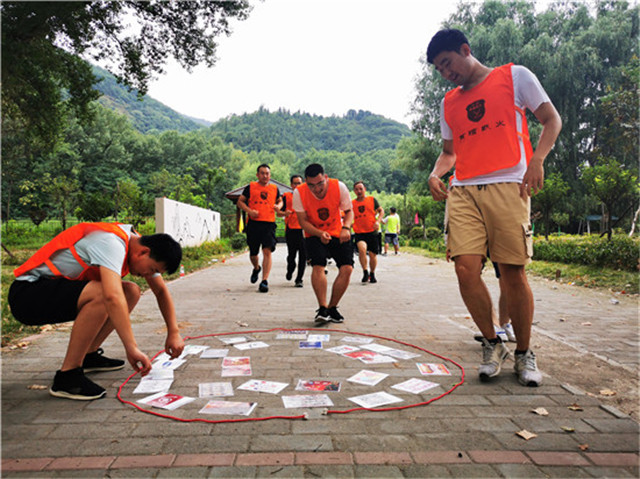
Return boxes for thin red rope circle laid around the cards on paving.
[117,328,465,424]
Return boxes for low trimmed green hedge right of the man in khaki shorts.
[533,235,640,271]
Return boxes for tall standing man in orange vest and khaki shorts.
[427,29,562,386]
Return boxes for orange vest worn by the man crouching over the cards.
[13,223,129,281]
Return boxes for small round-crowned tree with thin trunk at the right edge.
[582,158,638,239]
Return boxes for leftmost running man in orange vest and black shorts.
[238,163,282,293]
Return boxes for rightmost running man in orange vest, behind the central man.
[352,181,384,283]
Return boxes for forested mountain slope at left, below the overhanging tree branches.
[93,66,211,133]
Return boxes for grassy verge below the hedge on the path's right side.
[402,246,640,294]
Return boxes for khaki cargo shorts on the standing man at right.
[446,183,533,265]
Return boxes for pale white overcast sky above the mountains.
[148,0,458,125]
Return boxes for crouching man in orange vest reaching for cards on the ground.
[8,223,184,401]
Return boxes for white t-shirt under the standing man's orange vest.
[440,65,551,186]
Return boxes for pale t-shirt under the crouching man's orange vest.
[16,225,133,281]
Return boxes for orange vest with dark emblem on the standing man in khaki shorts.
[444,63,533,180]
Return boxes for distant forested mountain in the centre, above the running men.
[210,108,411,154]
